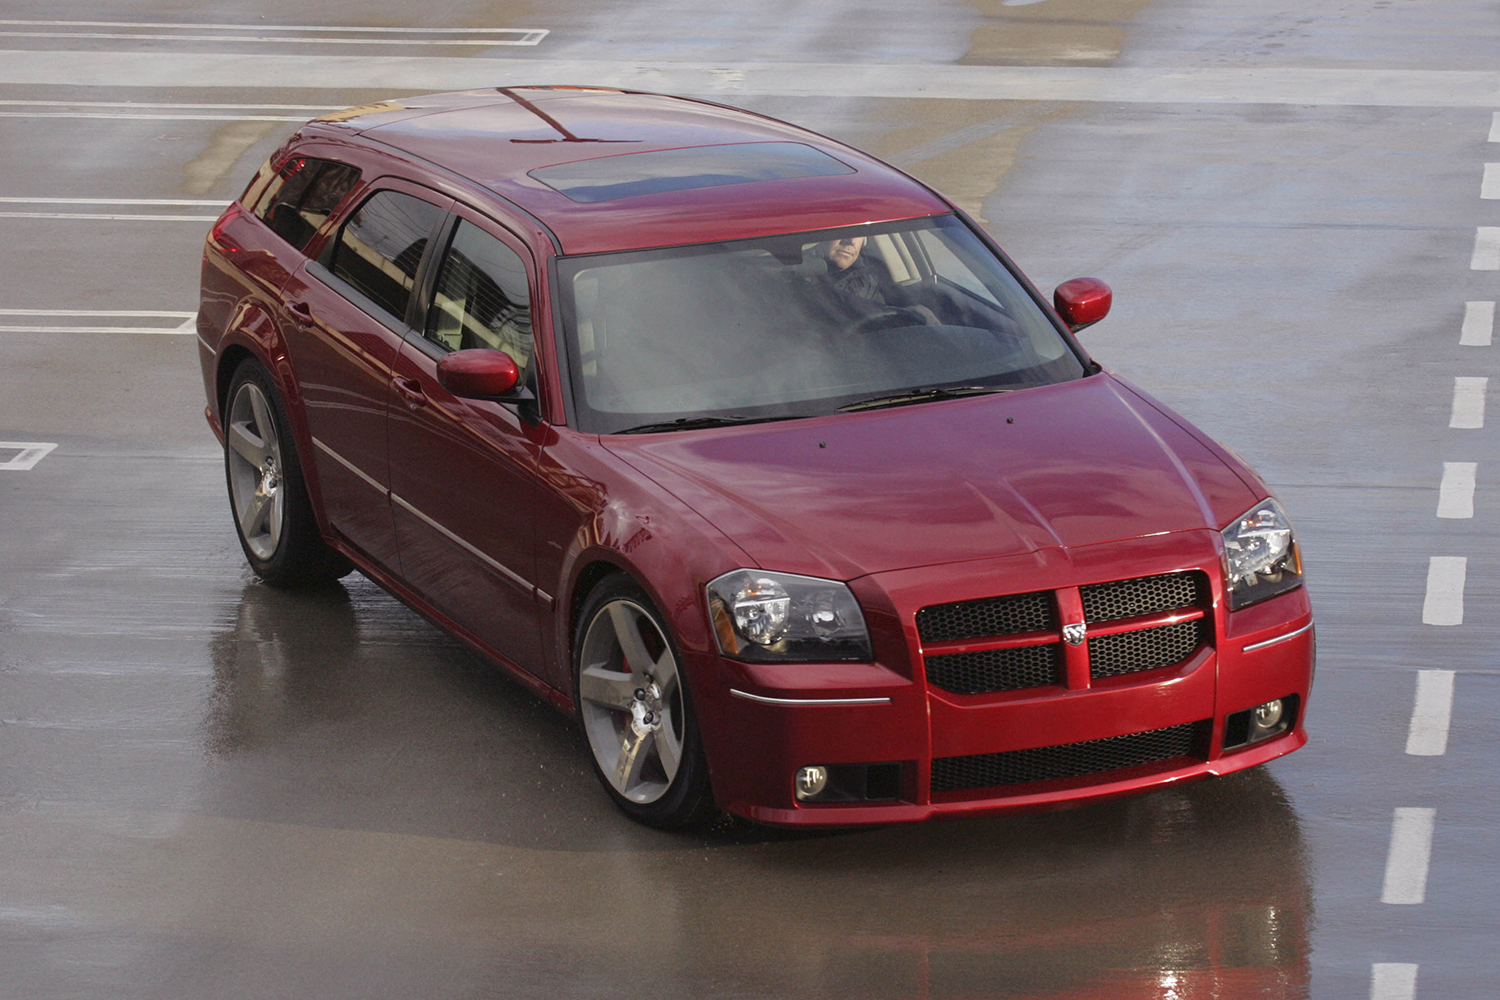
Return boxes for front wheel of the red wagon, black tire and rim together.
[573,576,716,829]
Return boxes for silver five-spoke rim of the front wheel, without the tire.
[578,598,687,805]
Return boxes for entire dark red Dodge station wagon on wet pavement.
[198,87,1314,826]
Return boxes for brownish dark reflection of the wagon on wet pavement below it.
[200,576,1311,1000]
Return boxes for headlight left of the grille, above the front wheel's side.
[708,570,872,663]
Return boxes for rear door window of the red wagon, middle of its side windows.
[332,190,444,319]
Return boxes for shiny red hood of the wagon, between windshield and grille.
[603,373,1262,580]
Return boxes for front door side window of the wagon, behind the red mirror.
[426,222,531,372]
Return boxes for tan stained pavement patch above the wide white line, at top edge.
[959,0,1151,66]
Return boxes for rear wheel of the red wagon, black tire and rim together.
[224,358,354,588]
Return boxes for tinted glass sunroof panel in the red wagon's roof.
[531,142,855,202]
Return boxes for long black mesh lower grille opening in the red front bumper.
[932,723,1212,793]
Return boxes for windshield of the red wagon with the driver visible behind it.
[558,216,1085,433]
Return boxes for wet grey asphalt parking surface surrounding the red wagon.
[0,0,1500,1000]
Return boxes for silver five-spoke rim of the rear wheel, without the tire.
[225,382,287,559]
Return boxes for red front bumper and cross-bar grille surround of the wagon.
[692,532,1314,826]
